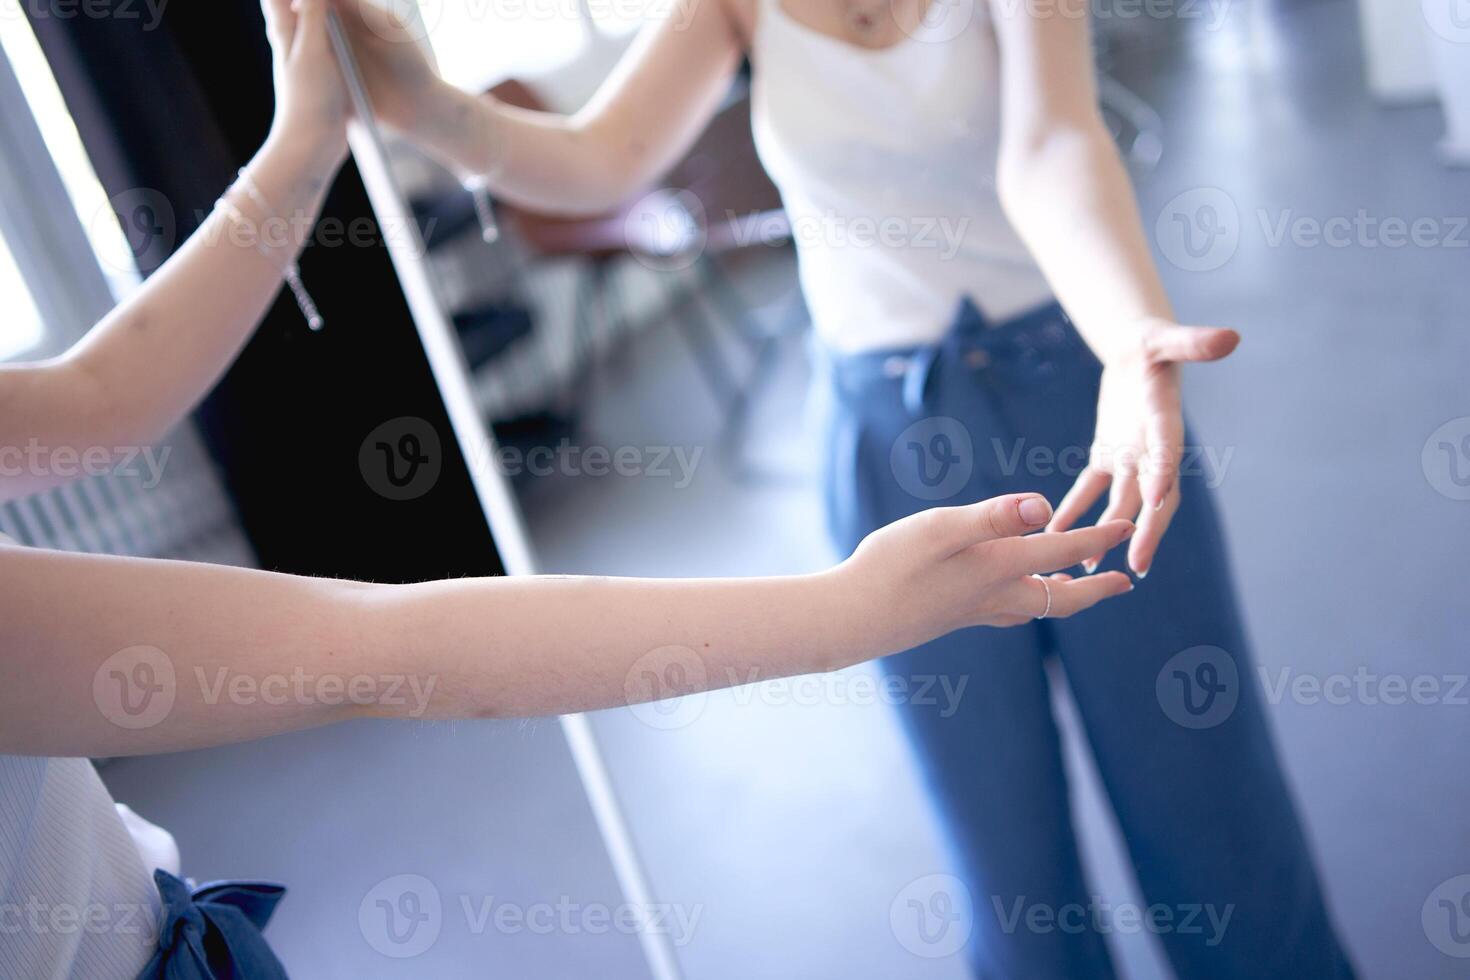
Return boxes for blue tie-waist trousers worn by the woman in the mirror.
[817,303,1352,980]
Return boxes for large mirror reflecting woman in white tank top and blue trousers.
[330,0,1470,977]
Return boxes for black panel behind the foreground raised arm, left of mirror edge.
[28,0,503,582]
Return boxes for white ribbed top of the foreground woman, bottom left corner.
[0,535,168,980]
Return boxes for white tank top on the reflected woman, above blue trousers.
[751,0,1051,351]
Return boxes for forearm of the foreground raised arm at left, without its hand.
[0,138,338,500]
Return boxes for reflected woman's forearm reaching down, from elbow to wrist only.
[1000,119,1173,363]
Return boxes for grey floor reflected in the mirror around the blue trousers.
[532,0,1470,977]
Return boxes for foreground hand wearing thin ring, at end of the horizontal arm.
[835,494,1133,654]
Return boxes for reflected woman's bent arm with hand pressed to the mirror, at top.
[332,0,742,215]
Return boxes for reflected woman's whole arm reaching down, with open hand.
[991,0,1239,576]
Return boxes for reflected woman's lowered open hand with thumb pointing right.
[1048,320,1241,577]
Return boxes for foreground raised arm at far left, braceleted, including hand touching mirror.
[0,0,347,500]
